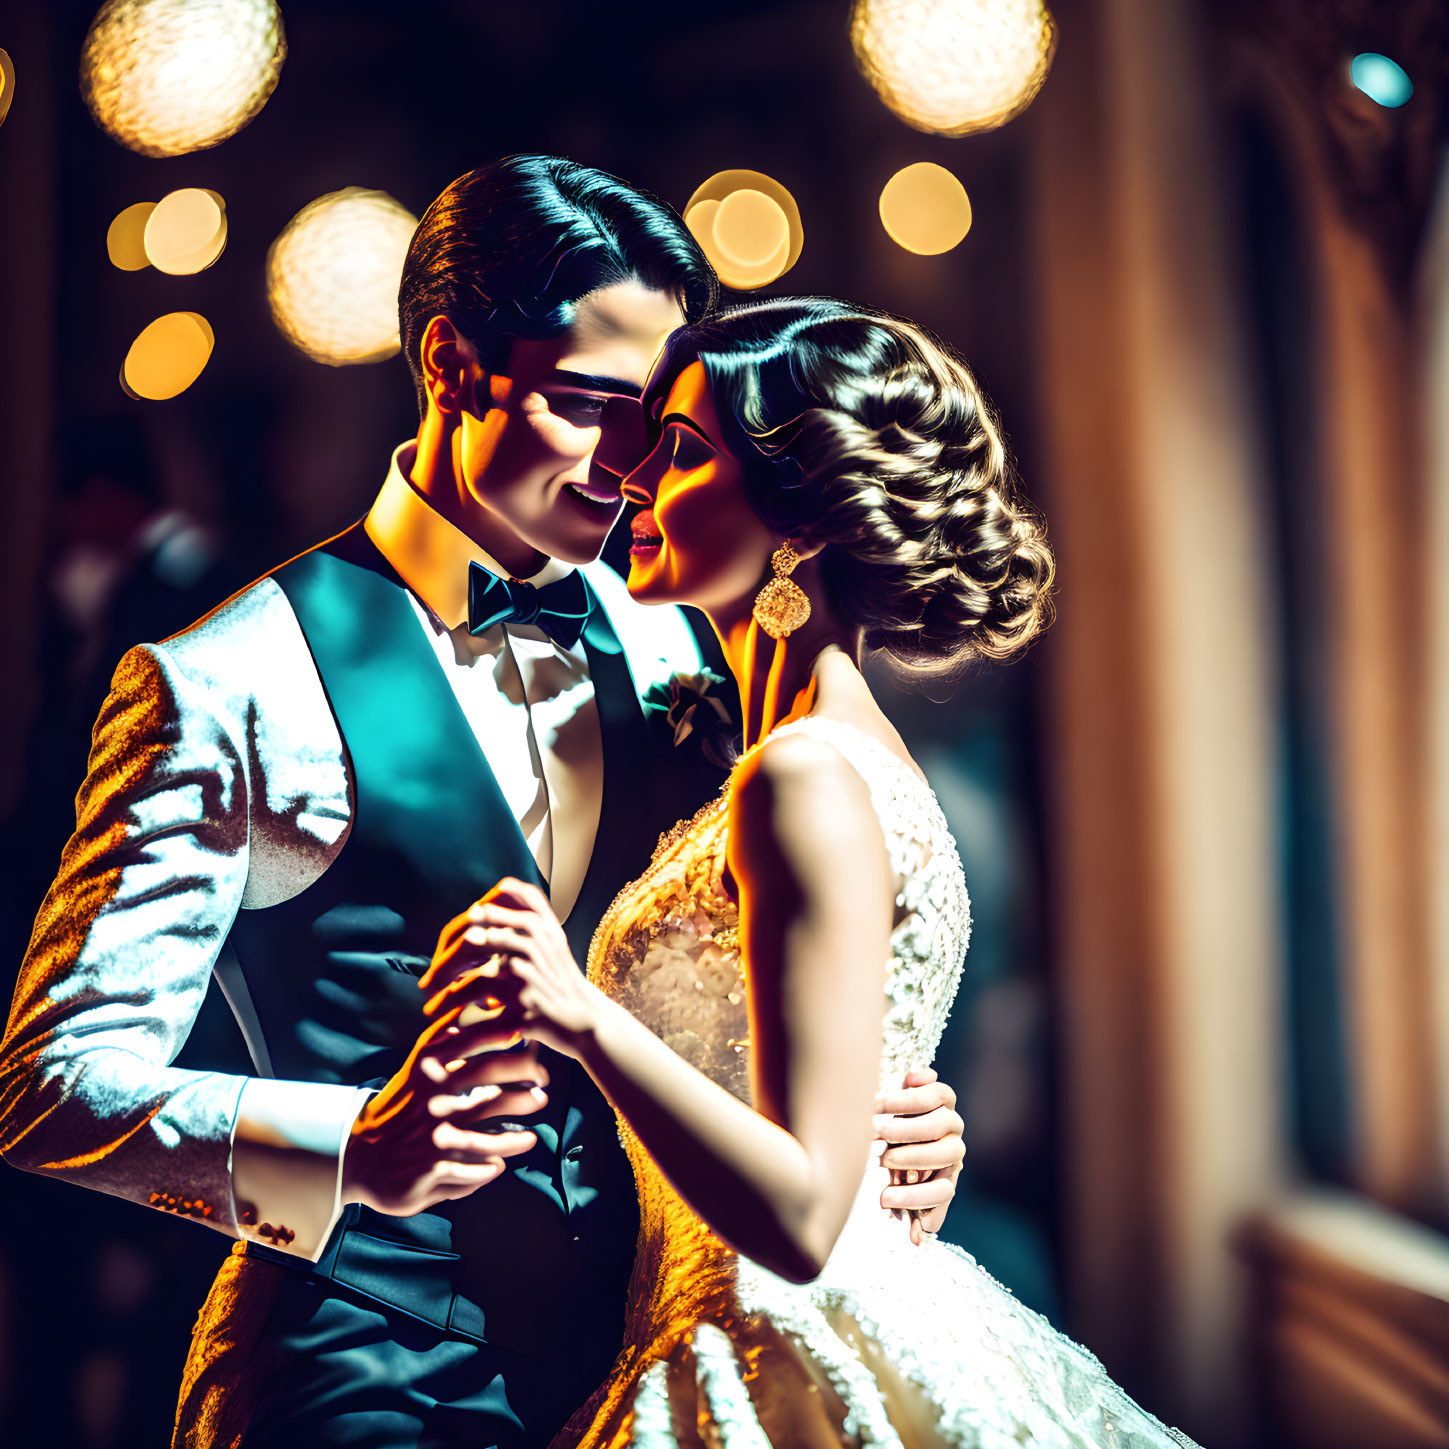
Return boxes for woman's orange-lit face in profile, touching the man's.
[623,362,778,619]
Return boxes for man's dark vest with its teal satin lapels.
[230,525,720,1375]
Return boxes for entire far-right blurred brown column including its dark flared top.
[1229,0,1449,1216]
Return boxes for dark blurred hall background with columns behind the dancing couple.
[0,0,1449,1449]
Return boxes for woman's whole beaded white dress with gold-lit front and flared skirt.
[554,717,1191,1449]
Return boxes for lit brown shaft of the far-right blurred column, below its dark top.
[1304,105,1440,1211]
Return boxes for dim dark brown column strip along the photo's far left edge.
[0,0,57,819]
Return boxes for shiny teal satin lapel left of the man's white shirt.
[274,525,546,910]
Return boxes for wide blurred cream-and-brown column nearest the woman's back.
[1033,0,1282,1443]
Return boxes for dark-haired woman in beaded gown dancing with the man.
[425,300,1188,1449]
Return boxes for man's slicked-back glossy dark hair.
[397,155,719,413]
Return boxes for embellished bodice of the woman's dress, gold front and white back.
[588,717,971,1345]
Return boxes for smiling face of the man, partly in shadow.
[454,280,684,567]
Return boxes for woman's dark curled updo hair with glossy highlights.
[645,297,1055,680]
